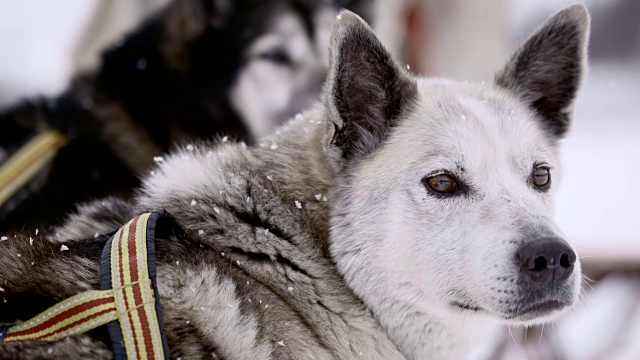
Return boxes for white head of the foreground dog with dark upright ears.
[325,5,589,324]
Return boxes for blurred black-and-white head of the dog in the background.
[164,0,369,138]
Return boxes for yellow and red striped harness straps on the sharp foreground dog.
[0,212,171,359]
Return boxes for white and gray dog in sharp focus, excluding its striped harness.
[0,5,589,359]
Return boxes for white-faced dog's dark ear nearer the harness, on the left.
[325,11,417,160]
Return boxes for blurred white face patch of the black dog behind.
[231,6,336,137]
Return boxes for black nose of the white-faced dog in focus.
[516,238,576,285]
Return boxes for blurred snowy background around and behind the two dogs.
[0,0,640,359]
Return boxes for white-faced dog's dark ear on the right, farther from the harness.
[496,4,589,138]
